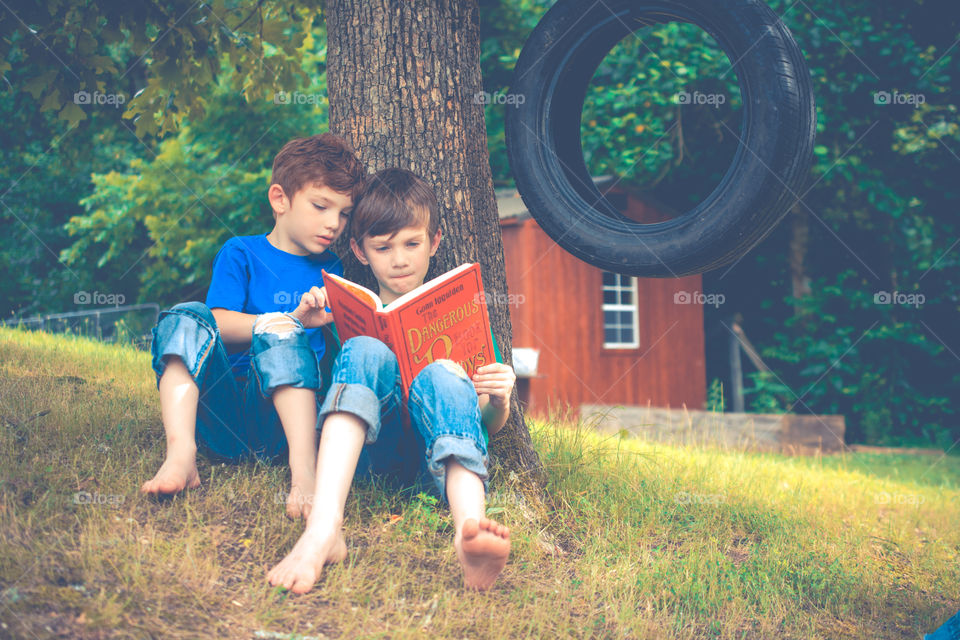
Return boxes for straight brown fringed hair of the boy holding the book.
[348,169,440,242]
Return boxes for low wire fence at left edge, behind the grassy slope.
[2,302,160,349]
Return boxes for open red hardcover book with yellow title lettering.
[323,263,496,394]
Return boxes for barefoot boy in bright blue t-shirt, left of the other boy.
[141,133,365,518]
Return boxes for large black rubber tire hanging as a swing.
[506,0,816,277]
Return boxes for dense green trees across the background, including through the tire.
[0,0,960,448]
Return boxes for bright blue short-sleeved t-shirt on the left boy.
[207,234,343,375]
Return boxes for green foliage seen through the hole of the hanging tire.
[581,22,741,190]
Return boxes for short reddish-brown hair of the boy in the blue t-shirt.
[270,133,367,201]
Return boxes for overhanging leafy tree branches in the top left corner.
[0,0,320,137]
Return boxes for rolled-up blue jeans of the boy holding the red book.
[318,336,488,499]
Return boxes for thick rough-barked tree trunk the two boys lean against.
[325,0,543,484]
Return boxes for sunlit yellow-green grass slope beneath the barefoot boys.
[0,329,960,639]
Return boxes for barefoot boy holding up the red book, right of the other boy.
[267,169,516,593]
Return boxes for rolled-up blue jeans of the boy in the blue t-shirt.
[150,302,329,462]
